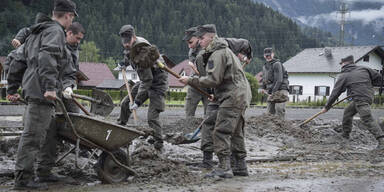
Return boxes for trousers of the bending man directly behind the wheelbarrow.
[119,83,165,140]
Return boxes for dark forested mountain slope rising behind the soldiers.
[0,0,333,74]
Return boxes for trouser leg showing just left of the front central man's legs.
[200,102,219,152]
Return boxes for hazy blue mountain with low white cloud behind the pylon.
[253,0,384,45]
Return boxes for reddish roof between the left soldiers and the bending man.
[79,62,115,87]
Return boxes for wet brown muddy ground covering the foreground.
[0,109,384,192]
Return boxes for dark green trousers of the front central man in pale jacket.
[212,107,247,158]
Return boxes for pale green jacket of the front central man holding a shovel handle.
[188,37,252,108]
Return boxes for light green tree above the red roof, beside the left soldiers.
[80,41,100,62]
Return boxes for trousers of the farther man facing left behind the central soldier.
[185,86,208,117]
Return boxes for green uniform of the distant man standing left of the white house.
[261,54,289,119]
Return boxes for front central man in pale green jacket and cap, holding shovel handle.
[180,24,252,178]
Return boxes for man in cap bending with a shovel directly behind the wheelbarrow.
[119,25,168,151]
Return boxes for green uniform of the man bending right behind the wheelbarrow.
[119,37,168,149]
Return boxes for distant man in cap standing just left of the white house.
[261,48,289,119]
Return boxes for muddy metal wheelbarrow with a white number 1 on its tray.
[56,99,145,183]
